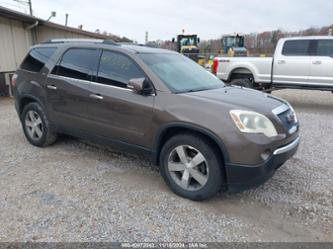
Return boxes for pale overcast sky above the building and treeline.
[0,0,333,43]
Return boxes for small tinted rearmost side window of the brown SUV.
[21,48,56,72]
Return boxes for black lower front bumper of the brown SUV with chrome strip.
[226,137,300,192]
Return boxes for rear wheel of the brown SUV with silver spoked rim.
[21,102,57,147]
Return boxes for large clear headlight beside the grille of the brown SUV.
[230,110,277,137]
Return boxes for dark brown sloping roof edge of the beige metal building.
[0,6,131,42]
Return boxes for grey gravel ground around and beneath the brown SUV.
[0,90,333,242]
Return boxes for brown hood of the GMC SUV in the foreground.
[185,86,285,113]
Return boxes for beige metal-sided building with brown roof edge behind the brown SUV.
[0,6,130,96]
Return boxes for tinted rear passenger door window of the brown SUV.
[52,48,99,80]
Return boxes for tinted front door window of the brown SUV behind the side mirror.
[97,51,146,87]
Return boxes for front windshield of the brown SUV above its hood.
[139,53,224,93]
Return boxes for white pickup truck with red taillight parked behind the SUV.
[212,36,333,91]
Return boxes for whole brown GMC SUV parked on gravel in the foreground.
[12,40,300,200]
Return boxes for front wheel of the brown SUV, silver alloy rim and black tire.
[160,134,223,201]
